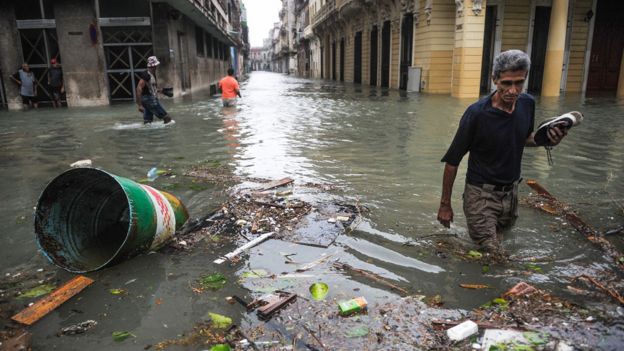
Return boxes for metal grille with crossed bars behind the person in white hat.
[102,26,154,101]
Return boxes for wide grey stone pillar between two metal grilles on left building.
[54,0,109,106]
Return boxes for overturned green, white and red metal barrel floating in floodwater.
[35,168,189,273]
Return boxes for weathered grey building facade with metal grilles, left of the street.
[0,0,248,109]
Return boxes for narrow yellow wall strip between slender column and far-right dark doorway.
[565,0,592,92]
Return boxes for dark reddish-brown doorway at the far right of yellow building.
[587,0,624,92]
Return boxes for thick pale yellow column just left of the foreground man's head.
[451,0,485,98]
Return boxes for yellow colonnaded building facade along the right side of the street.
[304,0,624,98]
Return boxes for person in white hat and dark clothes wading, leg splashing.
[136,56,171,124]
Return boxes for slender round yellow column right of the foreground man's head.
[542,0,569,96]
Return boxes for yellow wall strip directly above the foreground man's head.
[501,0,531,51]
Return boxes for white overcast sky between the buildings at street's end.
[243,0,282,47]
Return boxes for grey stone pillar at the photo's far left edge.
[0,1,23,110]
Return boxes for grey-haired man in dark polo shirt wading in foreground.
[438,50,567,259]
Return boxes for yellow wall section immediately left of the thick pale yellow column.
[412,0,455,94]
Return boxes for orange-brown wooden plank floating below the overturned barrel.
[11,275,93,325]
